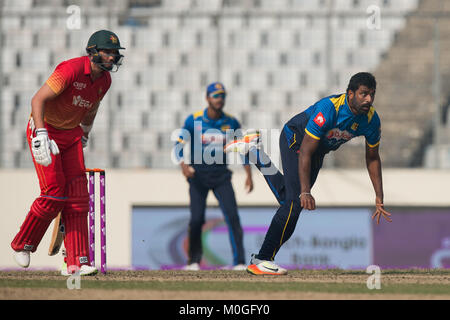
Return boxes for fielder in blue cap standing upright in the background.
[175,82,253,270]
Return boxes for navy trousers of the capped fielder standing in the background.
[188,166,245,265]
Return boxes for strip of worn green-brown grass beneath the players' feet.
[0,269,450,299]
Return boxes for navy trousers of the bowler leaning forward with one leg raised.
[249,117,324,260]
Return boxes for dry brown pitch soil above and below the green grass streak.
[0,270,450,300]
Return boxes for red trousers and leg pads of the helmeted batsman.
[11,120,90,266]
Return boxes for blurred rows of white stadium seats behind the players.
[0,0,428,168]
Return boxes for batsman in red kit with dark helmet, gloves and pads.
[11,30,125,275]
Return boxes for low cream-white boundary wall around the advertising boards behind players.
[0,169,450,269]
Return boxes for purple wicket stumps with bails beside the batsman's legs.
[86,168,106,273]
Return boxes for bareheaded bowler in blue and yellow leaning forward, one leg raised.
[225,72,392,275]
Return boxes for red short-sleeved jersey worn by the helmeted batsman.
[44,56,111,129]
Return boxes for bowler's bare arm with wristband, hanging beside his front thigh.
[298,133,320,210]
